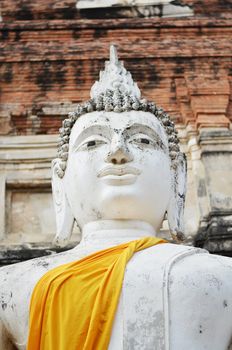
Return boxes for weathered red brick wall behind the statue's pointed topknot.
[0,0,232,135]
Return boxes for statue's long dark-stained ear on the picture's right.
[167,153,187,241]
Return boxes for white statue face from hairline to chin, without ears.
[63,111,171,230]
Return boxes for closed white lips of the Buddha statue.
[98,165,141,186]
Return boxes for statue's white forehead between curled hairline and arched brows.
[70,111,167,144]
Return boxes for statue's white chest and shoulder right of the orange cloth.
[109,247,232,350]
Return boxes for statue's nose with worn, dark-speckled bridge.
[106,140,133,164]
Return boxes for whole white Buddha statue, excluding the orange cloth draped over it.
[0,46,232,350]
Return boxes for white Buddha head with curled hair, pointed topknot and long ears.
[52,46,186,245]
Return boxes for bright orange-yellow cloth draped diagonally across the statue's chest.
[27,237,166,350]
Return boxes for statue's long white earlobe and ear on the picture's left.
[52,159,74,246]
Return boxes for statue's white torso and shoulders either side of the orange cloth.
[0,244,232,350]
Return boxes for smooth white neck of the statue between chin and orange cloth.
[80,220,155,249]
